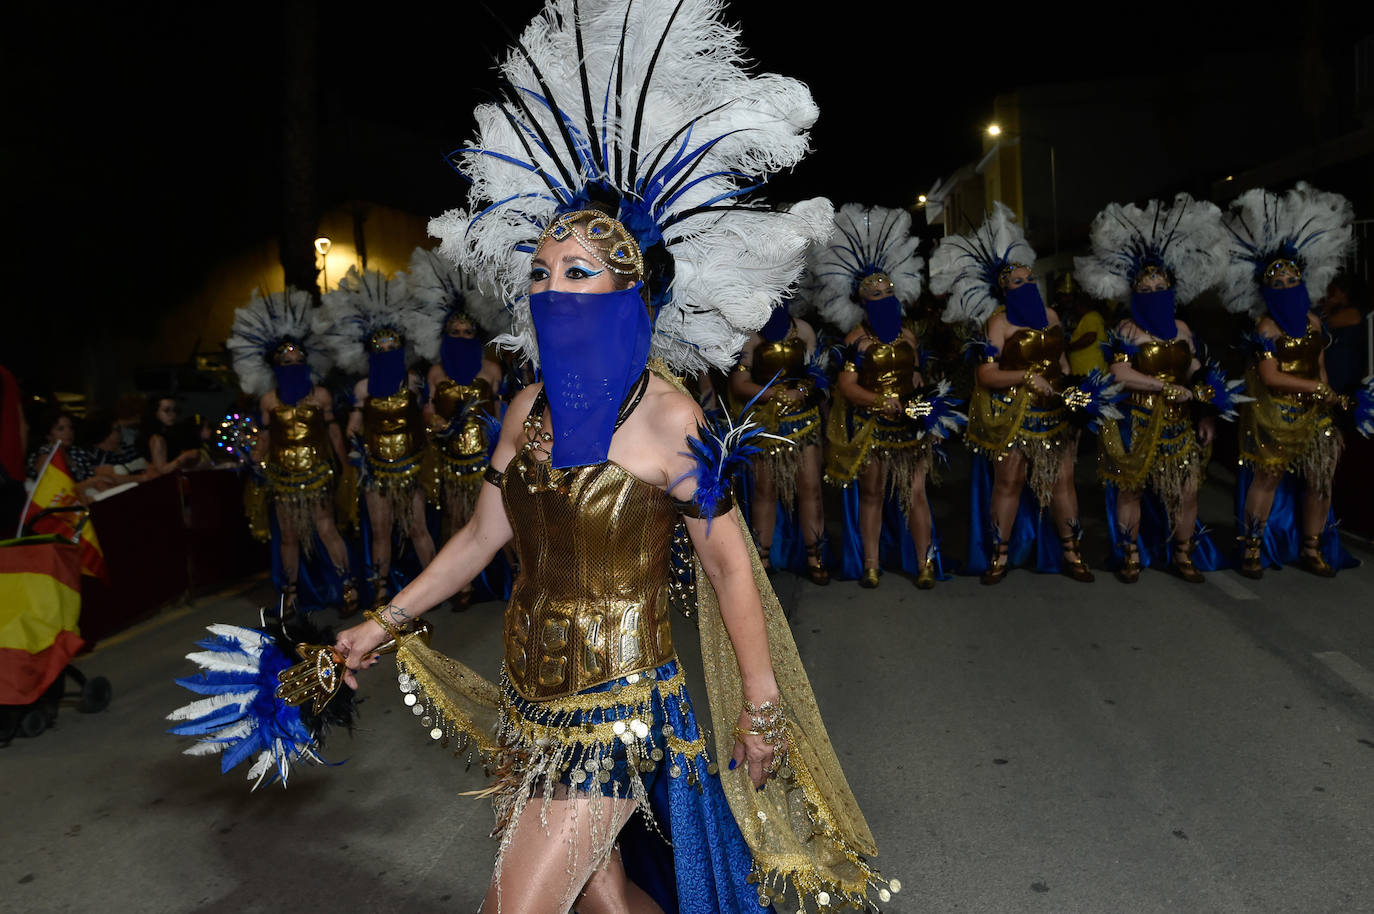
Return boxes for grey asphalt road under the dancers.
[0,467,1374,914]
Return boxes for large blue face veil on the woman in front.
[529,283,653,469]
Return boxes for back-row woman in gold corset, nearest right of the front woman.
[730,301,830,584]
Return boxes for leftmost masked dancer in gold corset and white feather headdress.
[225,289,357,614]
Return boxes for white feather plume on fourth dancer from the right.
[811,203,926,333]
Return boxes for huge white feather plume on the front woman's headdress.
[430,0,831,372]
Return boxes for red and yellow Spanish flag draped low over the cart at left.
[0,537,85,705]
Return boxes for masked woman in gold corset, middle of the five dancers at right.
[930,202,1094,584]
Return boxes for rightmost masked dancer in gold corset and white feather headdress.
[1224,183,1355,579]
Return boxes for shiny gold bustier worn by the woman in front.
[502,452,677,701]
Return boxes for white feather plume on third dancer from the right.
[930,201,1036,323]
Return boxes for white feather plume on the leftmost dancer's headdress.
[224,287,330,397]
